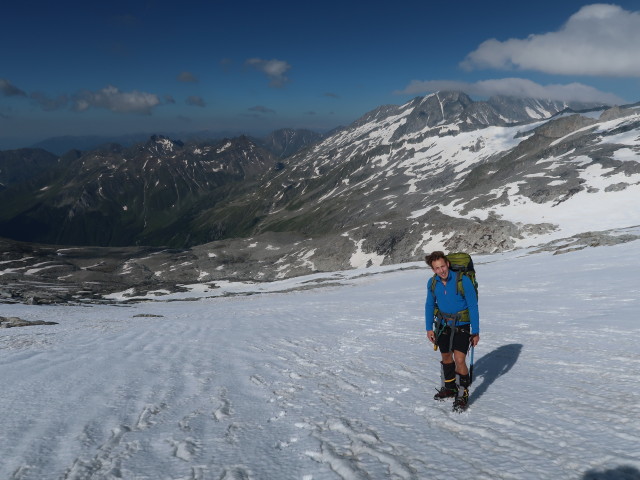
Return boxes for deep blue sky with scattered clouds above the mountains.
[0,0,640,148]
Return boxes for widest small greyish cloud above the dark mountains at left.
[73,85,160,114]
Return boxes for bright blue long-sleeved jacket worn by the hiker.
[424,270,480,333]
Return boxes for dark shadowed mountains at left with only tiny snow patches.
[0,136,276,246]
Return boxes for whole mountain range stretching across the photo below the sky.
[0,92,640,302]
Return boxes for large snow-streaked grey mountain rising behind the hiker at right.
[236,92,640,263]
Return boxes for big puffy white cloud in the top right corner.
[461,4,640,77]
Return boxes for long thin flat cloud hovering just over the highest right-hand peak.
[394,78,626,105]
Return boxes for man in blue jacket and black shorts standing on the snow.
[424,251,480,411]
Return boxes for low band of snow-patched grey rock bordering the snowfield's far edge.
[0,226,640,305]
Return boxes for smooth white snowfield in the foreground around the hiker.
[0,241,640,480]
